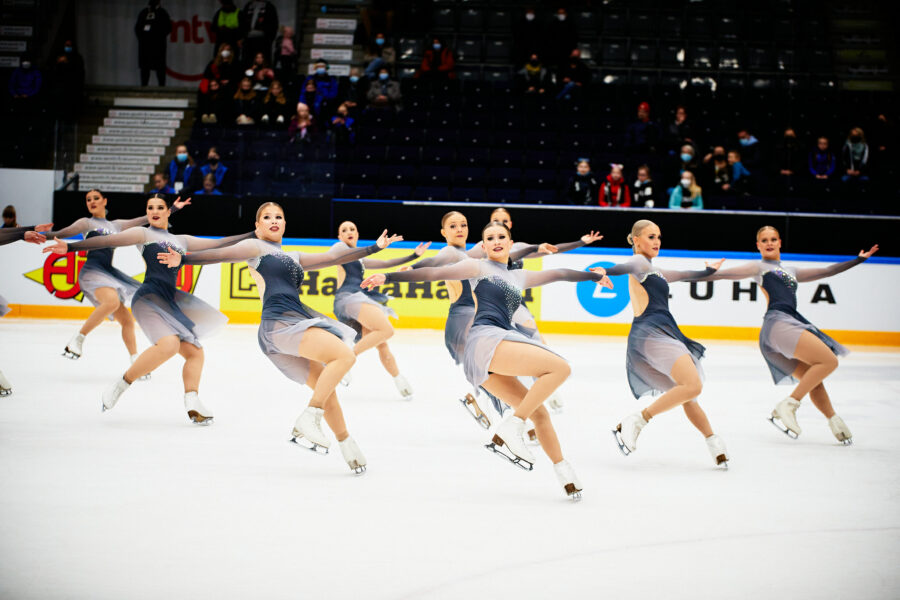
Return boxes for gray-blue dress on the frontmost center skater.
[386,259,601,390]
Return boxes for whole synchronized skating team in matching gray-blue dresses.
[0,190,878,499]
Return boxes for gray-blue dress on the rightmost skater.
[706,258,865,384]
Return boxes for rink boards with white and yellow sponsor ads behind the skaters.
[0,239,900,345]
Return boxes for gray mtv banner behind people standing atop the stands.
[77,0,297,88]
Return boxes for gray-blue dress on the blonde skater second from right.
[606,255,714,398]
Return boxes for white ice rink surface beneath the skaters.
[0,319,900,600]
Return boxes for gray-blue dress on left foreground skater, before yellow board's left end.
[184,239,379,384]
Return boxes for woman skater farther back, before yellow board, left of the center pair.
[331,221,431,400]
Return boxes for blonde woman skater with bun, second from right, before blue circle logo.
[606,219,728,468]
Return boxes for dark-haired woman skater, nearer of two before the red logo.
[44,194,253,425]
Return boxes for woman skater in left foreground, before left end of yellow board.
[160,202,403,473]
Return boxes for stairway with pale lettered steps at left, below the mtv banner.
[75,97,188,192]
